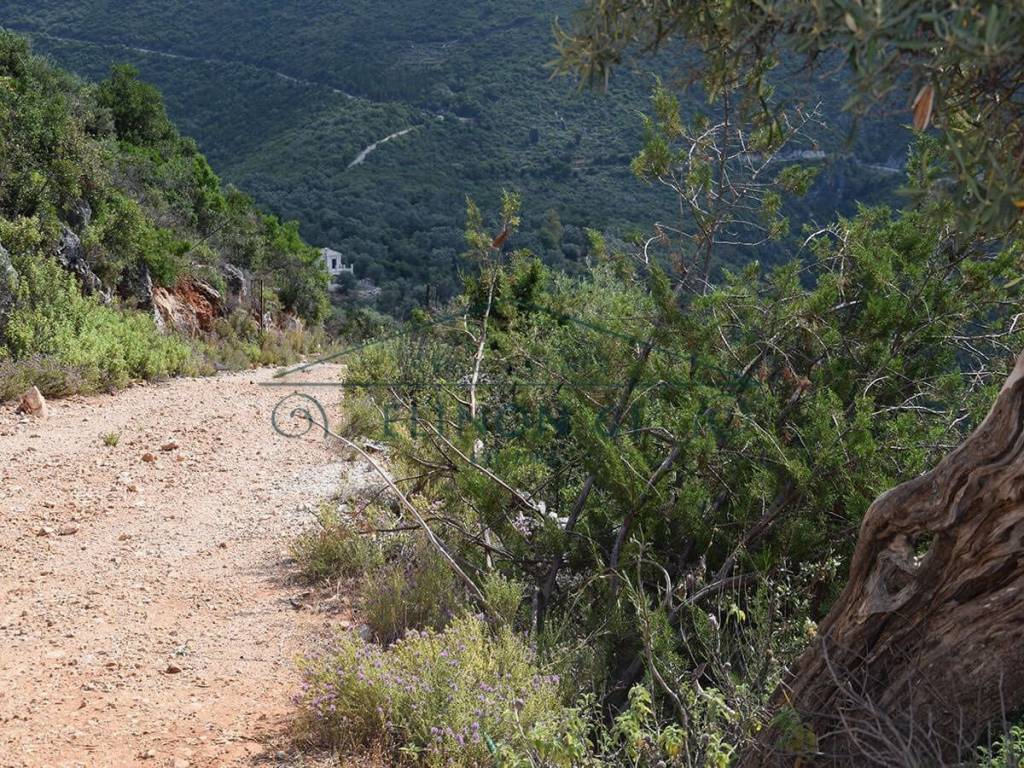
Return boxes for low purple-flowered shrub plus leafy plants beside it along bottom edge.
[296,612,770,768]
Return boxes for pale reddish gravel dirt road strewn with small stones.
[0,368,353,768]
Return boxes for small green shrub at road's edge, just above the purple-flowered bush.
[291,506,380,582]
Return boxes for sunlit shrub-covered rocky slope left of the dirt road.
[0,33,328,399]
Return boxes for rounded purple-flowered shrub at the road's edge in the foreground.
[298,616,589,766]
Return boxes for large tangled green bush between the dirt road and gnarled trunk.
[346,193,1024,765]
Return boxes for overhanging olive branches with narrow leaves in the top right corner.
[559,0,1024,233]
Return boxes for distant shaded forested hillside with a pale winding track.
[6,0,907,314]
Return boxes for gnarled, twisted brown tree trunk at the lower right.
[739,354,1024,768]
